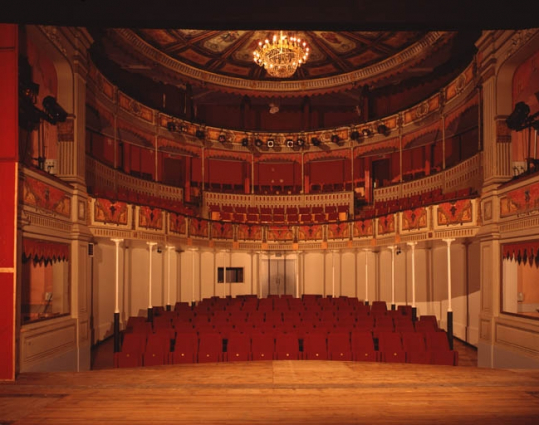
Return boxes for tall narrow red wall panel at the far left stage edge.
[0,24,19,380]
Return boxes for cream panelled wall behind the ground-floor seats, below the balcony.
[93,241,480,344]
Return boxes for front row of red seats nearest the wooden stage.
[114,331,458,367]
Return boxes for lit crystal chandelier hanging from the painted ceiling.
[253,31,309,78]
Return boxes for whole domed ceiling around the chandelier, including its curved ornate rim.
[92,29,473,97]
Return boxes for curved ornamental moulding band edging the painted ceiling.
[115,29,448,93]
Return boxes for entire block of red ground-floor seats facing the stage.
[114,296,458,367]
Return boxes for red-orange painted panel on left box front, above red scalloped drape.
[22,176,71,218]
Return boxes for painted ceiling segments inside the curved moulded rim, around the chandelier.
[133,29,426,80]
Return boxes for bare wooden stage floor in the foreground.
[0,361,539,425]
